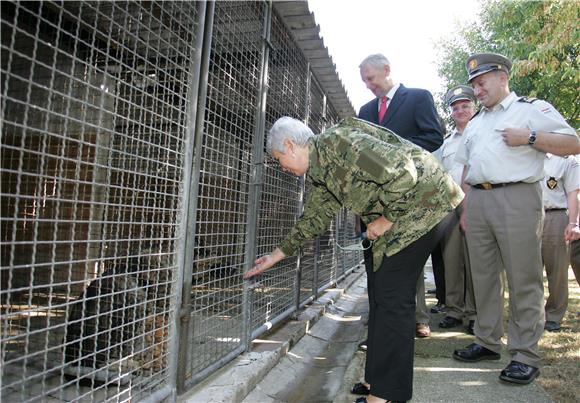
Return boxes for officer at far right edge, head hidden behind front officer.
[541,153,580,332]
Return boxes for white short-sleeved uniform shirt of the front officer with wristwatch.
[455,92,576,185]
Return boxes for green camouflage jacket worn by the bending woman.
[279,118,463,270]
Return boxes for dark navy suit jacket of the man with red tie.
[358,84,443,152]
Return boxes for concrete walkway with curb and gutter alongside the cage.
[178,267,552,403]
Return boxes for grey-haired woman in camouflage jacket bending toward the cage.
[245,117,463,402]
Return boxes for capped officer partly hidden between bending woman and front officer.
[434,85,475,334]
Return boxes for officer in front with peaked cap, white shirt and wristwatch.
[453,53,580,384]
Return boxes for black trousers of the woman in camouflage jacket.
[365,227,439,401]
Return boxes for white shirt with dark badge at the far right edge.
[541,154,580,209]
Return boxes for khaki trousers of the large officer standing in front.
[466,183,545,367]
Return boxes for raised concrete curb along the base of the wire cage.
[177,265,365,403]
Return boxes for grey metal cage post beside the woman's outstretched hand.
[242,1,272,351]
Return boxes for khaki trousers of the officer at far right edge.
[542,210,570,323]
